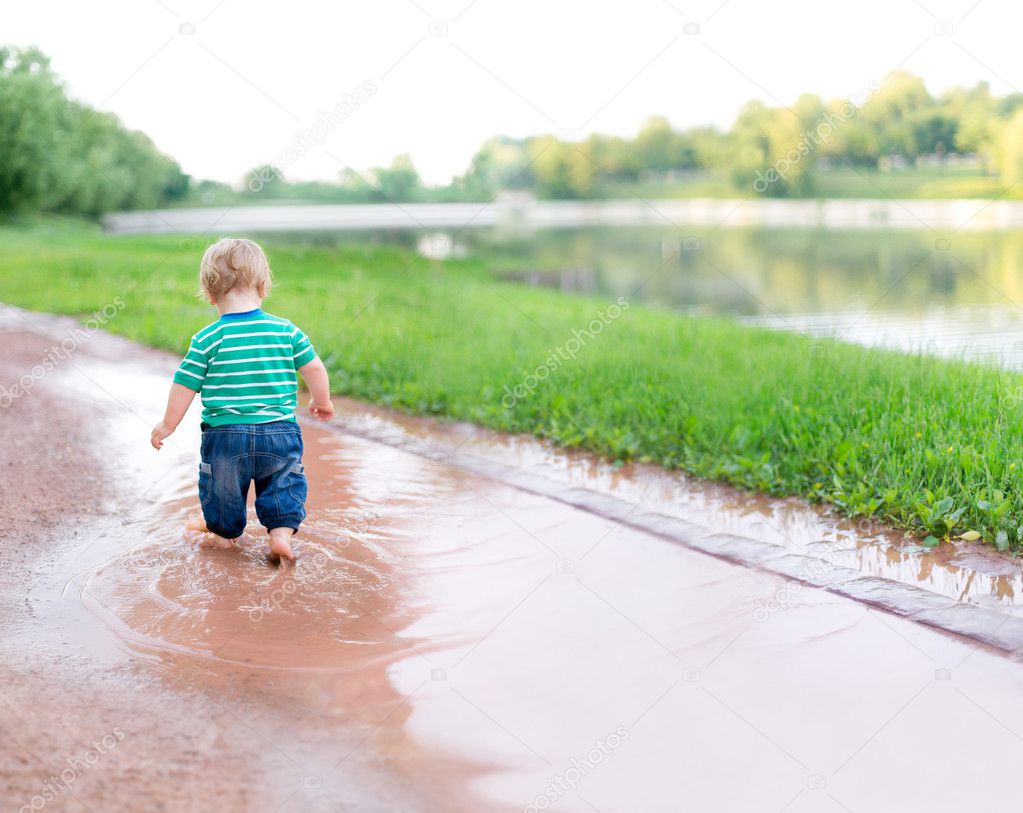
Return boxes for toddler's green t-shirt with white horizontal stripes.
[174,308,316,426]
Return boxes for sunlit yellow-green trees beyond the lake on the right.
[461,72,1023,198]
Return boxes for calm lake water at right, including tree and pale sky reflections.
[464,228,1023,369]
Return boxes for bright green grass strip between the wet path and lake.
[6,215,1023,547]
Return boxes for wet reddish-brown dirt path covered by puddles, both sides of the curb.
[0,312,1023,813]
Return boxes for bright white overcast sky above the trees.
[7,0,1023,184]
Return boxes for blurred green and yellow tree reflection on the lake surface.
[472,228,1023,314]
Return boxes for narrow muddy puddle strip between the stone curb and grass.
[329,402,1023,616]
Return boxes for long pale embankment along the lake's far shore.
[102,197,1023,234]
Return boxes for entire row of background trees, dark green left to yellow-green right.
[0,47,1023,217]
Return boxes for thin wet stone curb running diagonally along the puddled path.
[327,415,1023,660]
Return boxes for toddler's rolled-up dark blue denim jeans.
[198,420,307,539]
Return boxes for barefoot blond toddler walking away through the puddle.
[150,237,333,560]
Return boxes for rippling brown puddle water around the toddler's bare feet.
[82,517,401,671]
